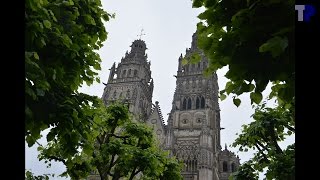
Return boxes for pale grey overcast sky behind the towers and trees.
[26,0,294,179]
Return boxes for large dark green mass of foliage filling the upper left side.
[25,0,112,156]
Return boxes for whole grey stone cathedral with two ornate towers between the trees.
[102,34,240,180]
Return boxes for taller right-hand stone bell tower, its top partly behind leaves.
[165,33,221,180]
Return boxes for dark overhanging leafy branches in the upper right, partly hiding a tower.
[193,0,295,105]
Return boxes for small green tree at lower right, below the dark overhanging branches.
[233,104,295,179]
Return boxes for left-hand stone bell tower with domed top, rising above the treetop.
[102,39,153,121]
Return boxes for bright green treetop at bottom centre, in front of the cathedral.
[40,101,182,180]
